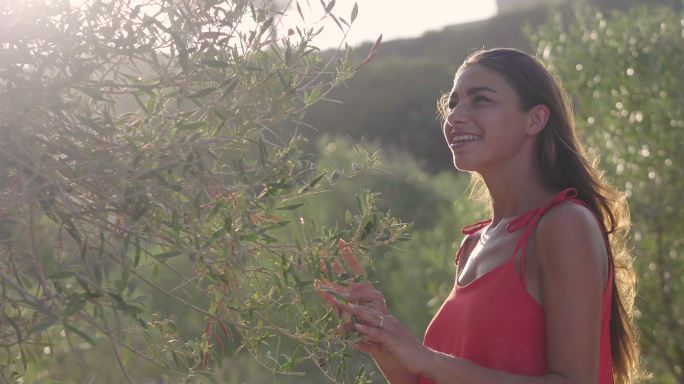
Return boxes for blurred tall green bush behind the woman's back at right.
[536,7,684,383]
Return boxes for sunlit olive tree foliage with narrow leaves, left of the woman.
[0,0,408,382]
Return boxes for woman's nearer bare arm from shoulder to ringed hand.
[345,204,607,384]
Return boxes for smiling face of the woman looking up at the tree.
[444,64,532,174]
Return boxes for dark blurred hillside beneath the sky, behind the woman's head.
[307,0,682,172]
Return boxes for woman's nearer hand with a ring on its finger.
[343,304,431,374]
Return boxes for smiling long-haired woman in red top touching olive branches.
[319,49,638,384]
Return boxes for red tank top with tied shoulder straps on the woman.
[419,188,613,384]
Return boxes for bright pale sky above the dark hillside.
[276,0,496,49]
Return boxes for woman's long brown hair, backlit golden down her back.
[439,48,640,384]
